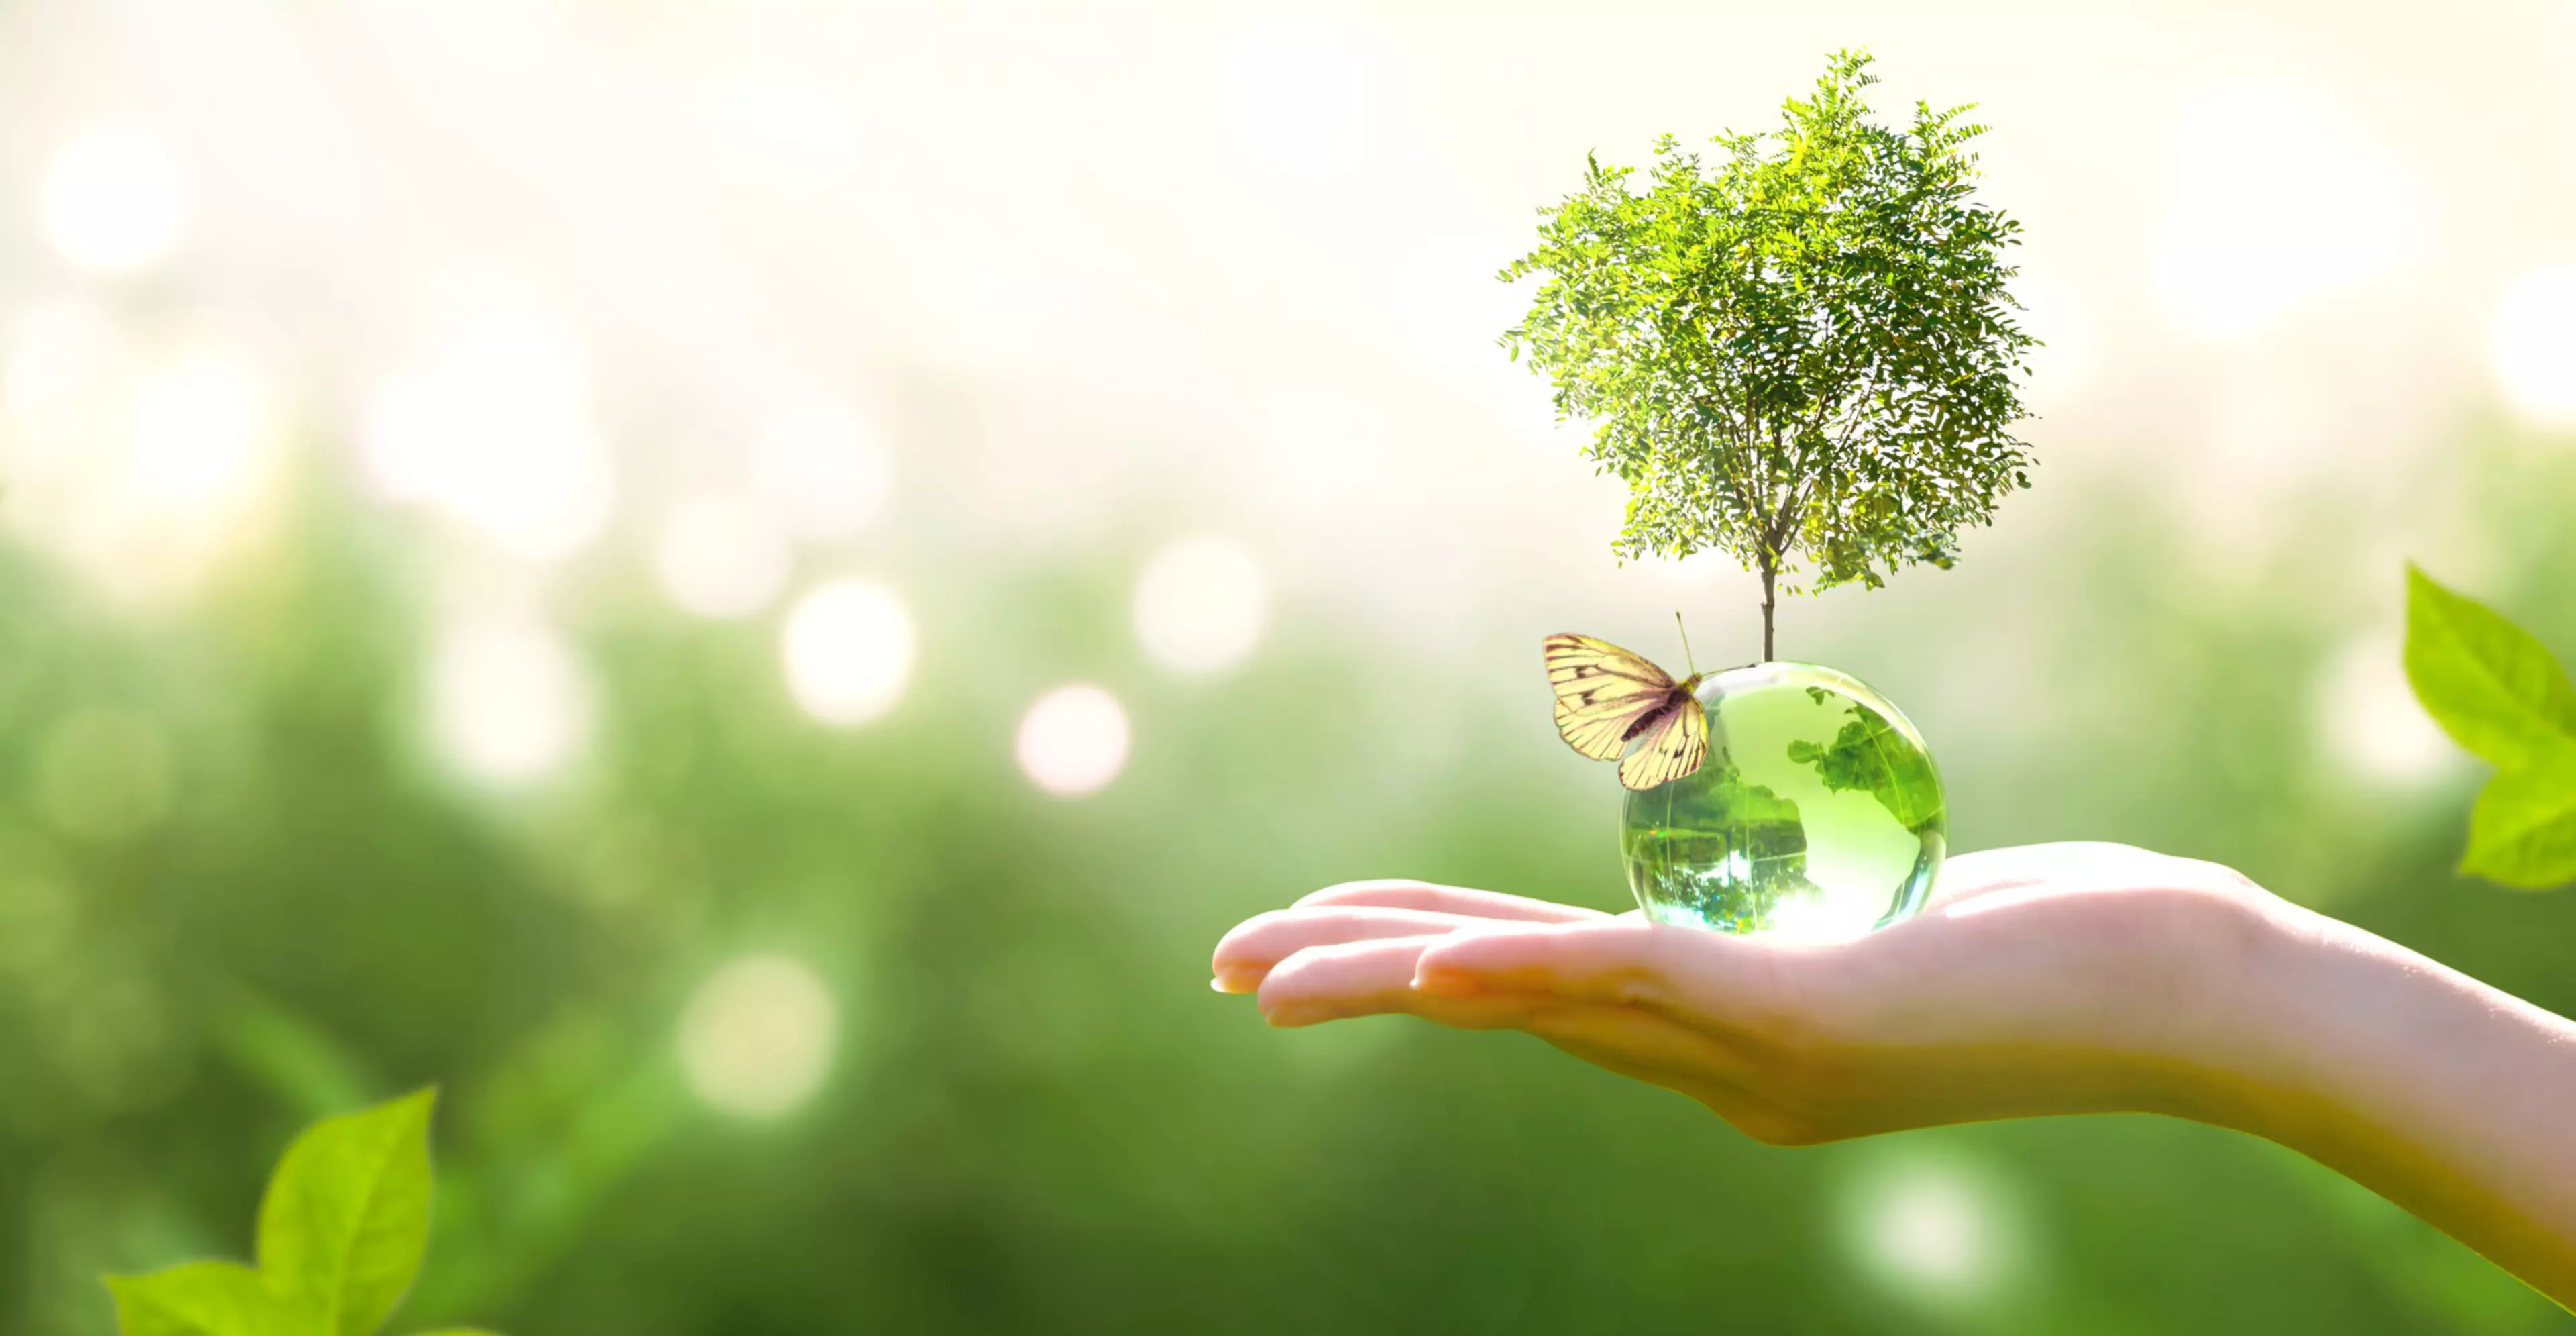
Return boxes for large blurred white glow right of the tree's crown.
[2156,85,2419,340]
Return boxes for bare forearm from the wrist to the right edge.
[2205,905,2576,1305]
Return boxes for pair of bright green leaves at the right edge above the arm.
[2406,568,2576,890]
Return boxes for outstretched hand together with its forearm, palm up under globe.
[1216,843,2576,1305]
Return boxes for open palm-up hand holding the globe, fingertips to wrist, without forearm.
[1214,843,2288,1145]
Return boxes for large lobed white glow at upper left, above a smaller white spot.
[361,309,613,560]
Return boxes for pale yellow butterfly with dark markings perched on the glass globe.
[1546,621,1708,789]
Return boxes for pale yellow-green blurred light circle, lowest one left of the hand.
[680,954,840,1117]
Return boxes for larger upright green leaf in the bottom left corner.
[260,1091,438,1336]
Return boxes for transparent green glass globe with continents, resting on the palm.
[1620,663,1950,939]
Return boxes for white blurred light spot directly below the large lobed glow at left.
[430,619,590,784]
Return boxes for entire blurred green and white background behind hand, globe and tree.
[0,0,2576,1336]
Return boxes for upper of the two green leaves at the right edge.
[2406,565,2576,768]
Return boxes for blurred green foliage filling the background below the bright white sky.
[0,431,2576,1336]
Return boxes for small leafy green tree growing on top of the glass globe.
[1502,52,2035,660]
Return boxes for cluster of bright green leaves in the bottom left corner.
[108,1091,489,1336]
